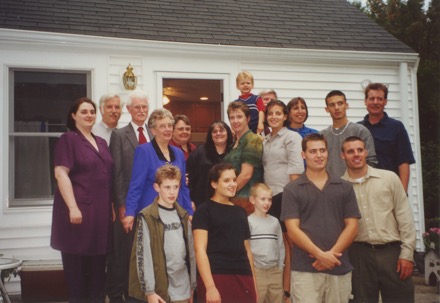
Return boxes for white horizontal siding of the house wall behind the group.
[0,30,424,292]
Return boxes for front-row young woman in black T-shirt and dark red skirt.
[192,163,256,303]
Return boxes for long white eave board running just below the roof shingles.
[0,28,419,64]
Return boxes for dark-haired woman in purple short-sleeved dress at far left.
[51,98,113,303]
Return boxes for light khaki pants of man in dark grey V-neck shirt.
[291,271,351,303]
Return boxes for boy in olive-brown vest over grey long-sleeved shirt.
[129,164,196,303]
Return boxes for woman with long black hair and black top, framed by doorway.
[186,121,233,207]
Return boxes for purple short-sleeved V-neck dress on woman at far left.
[51,131,113,255]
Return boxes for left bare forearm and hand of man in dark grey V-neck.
[285,219,342,269]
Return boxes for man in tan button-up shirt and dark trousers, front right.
[341,136,416,303]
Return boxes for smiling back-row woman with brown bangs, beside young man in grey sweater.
[287,97,318,138]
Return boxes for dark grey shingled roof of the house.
[0,0,414,53]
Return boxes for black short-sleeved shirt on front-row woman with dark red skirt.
[192,200,252,275]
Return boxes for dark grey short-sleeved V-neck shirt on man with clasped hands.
[281,174,360,275]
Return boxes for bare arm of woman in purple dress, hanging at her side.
[54,166,82,224]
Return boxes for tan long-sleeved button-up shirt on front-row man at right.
[342,166,416,261]
